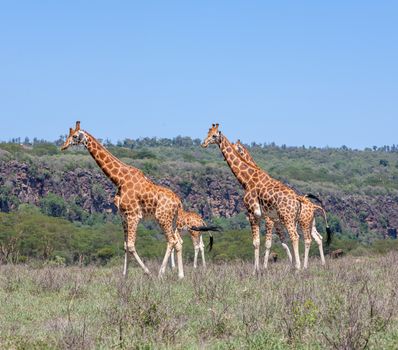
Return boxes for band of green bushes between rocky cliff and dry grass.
[0,204,398,264]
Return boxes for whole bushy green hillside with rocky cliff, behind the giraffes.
[0,137,398,263]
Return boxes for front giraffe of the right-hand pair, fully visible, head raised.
[202,124,301,273]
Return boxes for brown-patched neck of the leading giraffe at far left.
[84,131,130,186]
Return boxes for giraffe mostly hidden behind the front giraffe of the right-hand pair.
[233,140,330,268]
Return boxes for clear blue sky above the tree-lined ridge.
[0,0,398,148]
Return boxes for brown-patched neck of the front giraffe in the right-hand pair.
[219,135,258,189]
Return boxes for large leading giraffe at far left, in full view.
[61,121,205,278]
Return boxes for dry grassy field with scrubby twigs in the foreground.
[0,253,398,349]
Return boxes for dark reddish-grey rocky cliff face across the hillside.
[0,160,398,237]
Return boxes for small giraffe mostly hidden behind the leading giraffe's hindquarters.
[171,211,220,268]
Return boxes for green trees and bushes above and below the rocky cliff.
[0,137,398,264]
